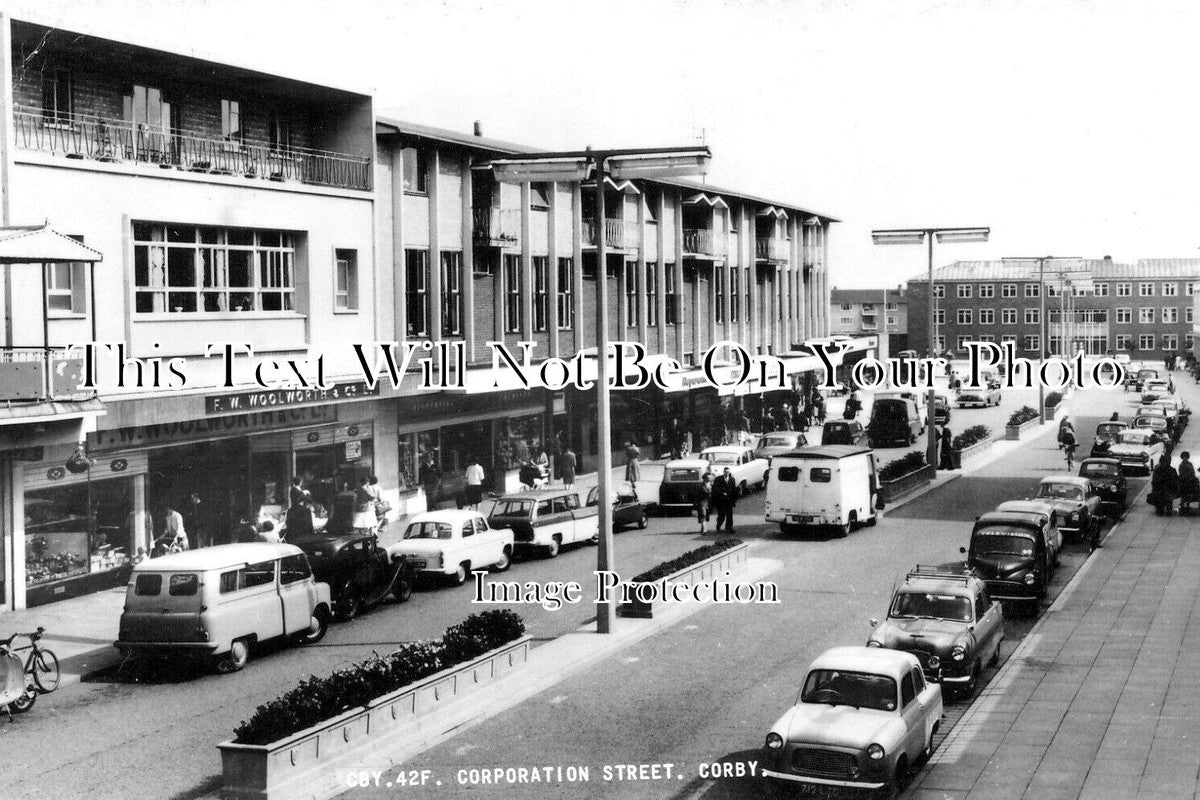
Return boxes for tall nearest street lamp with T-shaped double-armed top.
[491,146,713,633]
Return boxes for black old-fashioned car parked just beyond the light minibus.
[288,528,415,621]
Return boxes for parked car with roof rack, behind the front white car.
[866,565,1004,698]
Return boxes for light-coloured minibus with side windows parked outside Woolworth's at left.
[113,542,332,672]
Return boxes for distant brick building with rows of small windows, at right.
[908,258,1200,360]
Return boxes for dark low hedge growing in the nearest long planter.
[234,608,524,745]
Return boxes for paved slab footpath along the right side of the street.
[906,381,1200,800]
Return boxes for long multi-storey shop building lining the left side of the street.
[0,17,834,610]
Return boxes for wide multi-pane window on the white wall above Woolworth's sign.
[133,222,295,314]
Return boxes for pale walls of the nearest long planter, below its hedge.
[217,636,530,800]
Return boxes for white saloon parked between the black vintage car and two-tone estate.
[388,509,512,585]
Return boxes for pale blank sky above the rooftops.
[4,0,1200,288]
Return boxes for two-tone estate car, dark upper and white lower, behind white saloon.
[487,488,600,558]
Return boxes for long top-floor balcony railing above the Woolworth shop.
[13,107,371,191]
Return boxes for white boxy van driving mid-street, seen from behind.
[767,445,880,536]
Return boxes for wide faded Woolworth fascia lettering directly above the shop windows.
[88,405,337,450]
